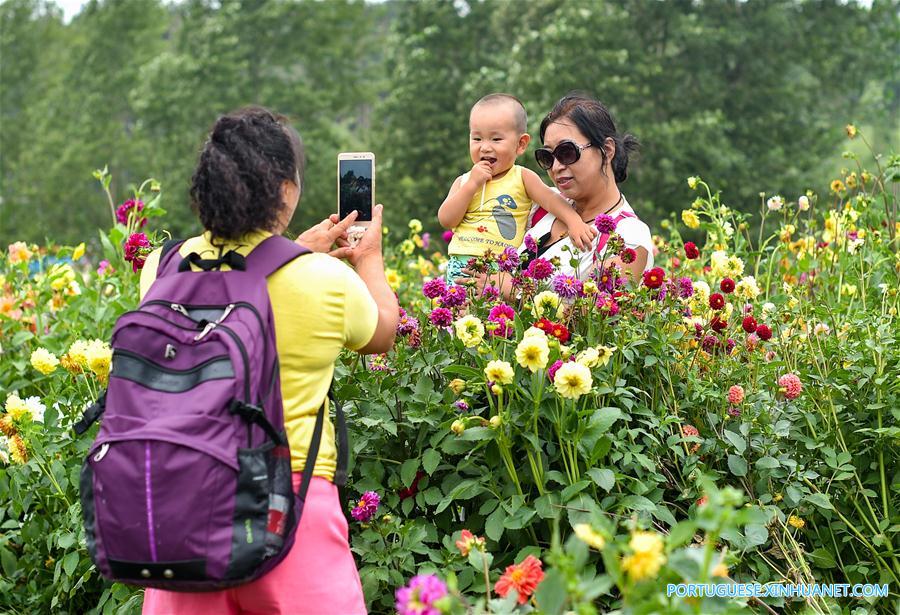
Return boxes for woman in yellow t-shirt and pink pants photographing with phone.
[141,107,399,615]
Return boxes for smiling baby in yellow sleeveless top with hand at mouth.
[438,94,597,281]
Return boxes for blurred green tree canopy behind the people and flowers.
[0,0,900,242]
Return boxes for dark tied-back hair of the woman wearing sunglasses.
[541,92,639,184]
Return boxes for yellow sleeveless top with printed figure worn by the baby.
[447,164,531,256]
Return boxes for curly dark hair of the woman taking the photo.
[190,107,306,239]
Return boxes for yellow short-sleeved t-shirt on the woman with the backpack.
[141,231,378,480]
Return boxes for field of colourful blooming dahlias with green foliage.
[0,134,900,615]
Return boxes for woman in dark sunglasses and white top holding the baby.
[522,94,653,279]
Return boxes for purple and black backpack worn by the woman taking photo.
[75,236,347,591]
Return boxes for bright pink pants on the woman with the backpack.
[143,473,366,615]
